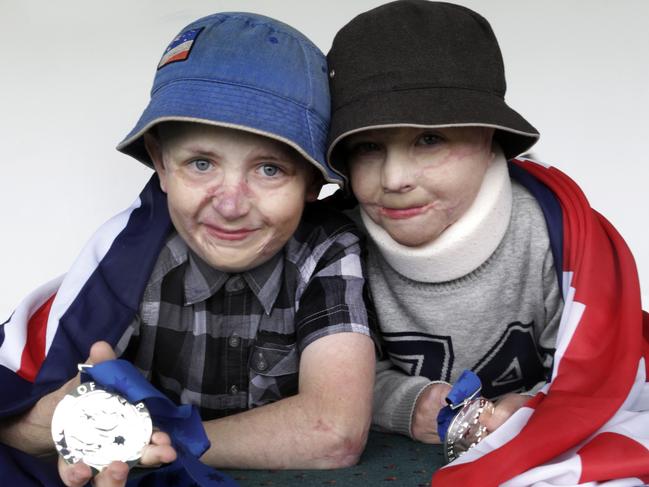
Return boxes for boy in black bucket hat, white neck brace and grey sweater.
[327,0,563,442]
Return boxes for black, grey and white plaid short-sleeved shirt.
[117,204,373,420]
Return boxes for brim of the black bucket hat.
[327,88,539,170]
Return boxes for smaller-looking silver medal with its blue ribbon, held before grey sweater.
[437,370,493,462]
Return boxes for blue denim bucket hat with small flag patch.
[117,12,342,183]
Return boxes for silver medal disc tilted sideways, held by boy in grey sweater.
[444,397,494,462]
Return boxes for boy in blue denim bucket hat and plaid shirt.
[2,13,374,486]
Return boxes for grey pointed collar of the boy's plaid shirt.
[184,244,284,314]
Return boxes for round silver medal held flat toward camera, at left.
[52,382,152,472]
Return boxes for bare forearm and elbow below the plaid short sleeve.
[202,333,374,469]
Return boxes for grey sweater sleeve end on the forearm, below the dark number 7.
[372,360,436,437]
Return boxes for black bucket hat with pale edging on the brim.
[327,0,539,175]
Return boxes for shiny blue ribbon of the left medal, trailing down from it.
[81,360,237,487]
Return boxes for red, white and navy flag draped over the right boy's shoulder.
[432,160,649,487]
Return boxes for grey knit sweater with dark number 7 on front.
[367,182,563,436]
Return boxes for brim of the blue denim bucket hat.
[117,80,342,183]
